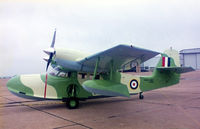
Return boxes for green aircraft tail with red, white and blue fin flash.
[140,54,181,92]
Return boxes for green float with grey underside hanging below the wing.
[83,80,130,97]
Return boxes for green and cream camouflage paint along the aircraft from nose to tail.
[7,54,180,99]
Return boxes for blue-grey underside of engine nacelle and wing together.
[55,45,160,72]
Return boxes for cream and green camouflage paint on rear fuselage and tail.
[121,54,180,93]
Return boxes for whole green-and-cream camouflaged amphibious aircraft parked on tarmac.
[7,31,180,109]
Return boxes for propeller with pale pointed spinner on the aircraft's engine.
[43,29,56,72]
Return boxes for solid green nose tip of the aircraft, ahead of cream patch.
[6,76,33,95]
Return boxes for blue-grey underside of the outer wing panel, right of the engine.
[78,45,160,72]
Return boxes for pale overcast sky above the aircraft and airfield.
[0,0,200,76]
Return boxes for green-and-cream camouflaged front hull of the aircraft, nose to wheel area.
[7,73,92,99]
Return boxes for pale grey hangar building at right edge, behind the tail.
[179,48,200,70]
